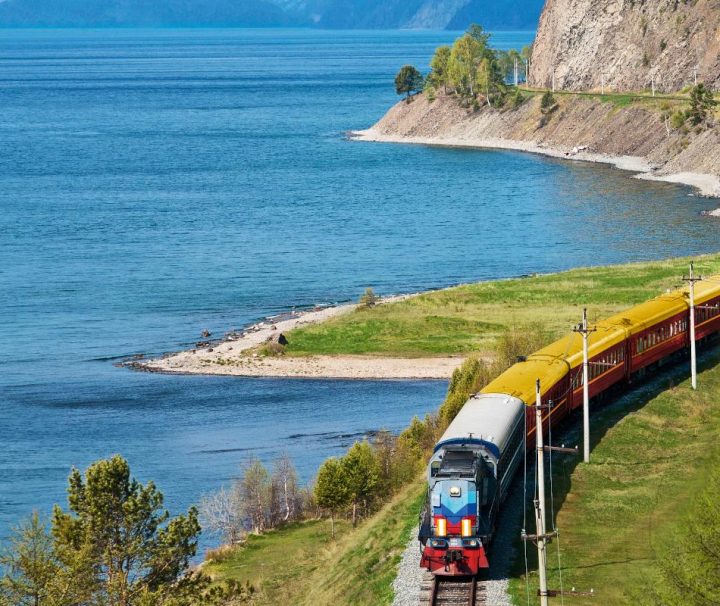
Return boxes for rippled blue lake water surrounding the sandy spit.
[0,30,720,548]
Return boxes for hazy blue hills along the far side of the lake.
[0,0,544,29]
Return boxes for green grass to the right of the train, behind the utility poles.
[511,347,720,606]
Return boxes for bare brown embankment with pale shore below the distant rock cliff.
[352,91,720,201]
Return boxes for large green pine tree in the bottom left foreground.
[52,456,200,606]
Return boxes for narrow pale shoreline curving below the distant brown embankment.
[348,127,720,202]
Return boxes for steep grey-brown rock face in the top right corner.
[530,0,720,92]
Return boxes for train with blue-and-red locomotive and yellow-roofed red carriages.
[418,275,720,577]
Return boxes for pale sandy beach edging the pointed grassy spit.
[134,294,464,379]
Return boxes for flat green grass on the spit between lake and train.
[287,255,720,356]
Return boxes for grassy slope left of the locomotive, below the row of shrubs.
[205,479,425,606]
